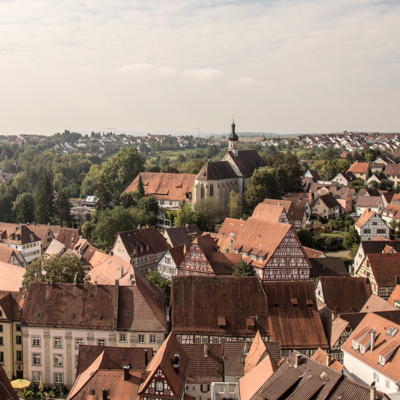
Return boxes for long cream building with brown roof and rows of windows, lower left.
[22,279,167,387]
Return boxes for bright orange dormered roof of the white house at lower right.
[342,313,400,382]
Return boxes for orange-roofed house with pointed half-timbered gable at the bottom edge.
[68,334,190,400]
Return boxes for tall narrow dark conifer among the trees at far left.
[35,175,54,224]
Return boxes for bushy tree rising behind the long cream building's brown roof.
[22,254,90,289]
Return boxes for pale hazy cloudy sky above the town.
[0,0,400,135]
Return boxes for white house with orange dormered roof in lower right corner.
[342,313,400,394]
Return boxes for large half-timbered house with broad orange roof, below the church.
[234,217,311,281]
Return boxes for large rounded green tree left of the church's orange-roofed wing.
[101,147,146,199]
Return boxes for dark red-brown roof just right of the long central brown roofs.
[320,276,372,314]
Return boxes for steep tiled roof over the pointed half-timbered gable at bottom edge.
[138,333,190,399]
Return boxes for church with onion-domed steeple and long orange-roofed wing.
[124,121,266,223]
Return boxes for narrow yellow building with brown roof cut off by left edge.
[0,290,27,380]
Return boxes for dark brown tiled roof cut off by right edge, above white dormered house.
[367,253,400,286]
